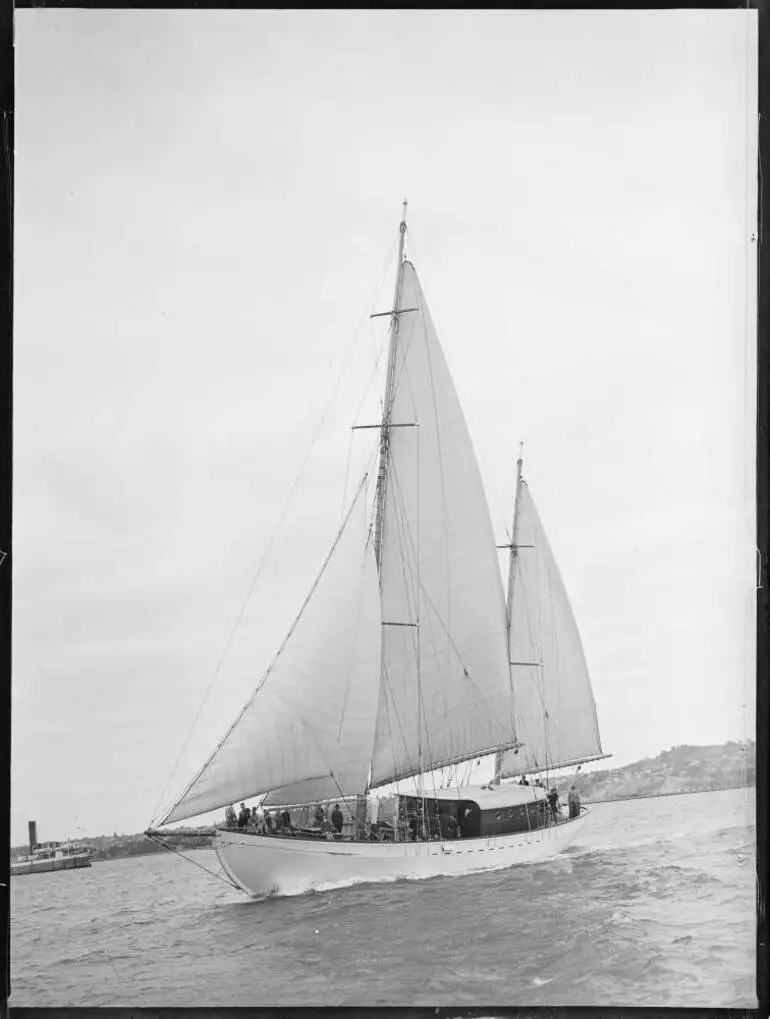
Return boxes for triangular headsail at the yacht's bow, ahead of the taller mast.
[159,485,381,822]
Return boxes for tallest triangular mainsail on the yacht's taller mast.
[372,262,514,785]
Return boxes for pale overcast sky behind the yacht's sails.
[12,9,757,844]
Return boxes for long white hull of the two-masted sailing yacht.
[216,813,586,897]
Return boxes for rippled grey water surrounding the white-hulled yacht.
[10,790,757,1007]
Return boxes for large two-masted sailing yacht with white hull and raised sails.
[149,202,606,896]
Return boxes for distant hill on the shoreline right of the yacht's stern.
[558,740,756,803]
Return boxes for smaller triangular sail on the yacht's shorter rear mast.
[502,482,602,777]
